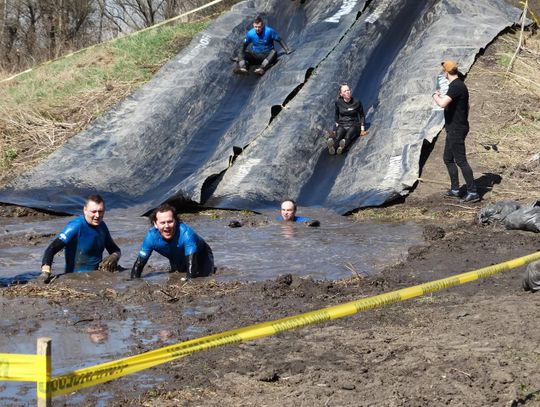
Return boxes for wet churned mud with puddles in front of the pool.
[0,209,540,406]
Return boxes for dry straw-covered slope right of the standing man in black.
[467,33,540,197]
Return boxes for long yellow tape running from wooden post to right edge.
[47,252,540,396]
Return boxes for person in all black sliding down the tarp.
[326,83,367,155]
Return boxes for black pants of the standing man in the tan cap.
[443,131,476,192]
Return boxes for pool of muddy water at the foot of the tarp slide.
[0,209,422,285]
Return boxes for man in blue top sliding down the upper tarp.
[235,16,292,75]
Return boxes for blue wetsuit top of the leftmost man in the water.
[57,215,118,273]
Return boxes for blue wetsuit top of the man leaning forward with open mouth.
[139,223,200,266]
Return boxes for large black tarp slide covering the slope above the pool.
[0,0,519,213]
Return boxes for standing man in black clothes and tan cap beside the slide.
[432,61,480,202]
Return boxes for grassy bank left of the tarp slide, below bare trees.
[0,21,208,184]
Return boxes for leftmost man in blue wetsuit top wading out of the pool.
[39,194,121,283]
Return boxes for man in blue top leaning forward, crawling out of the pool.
[131,204,215,279]
